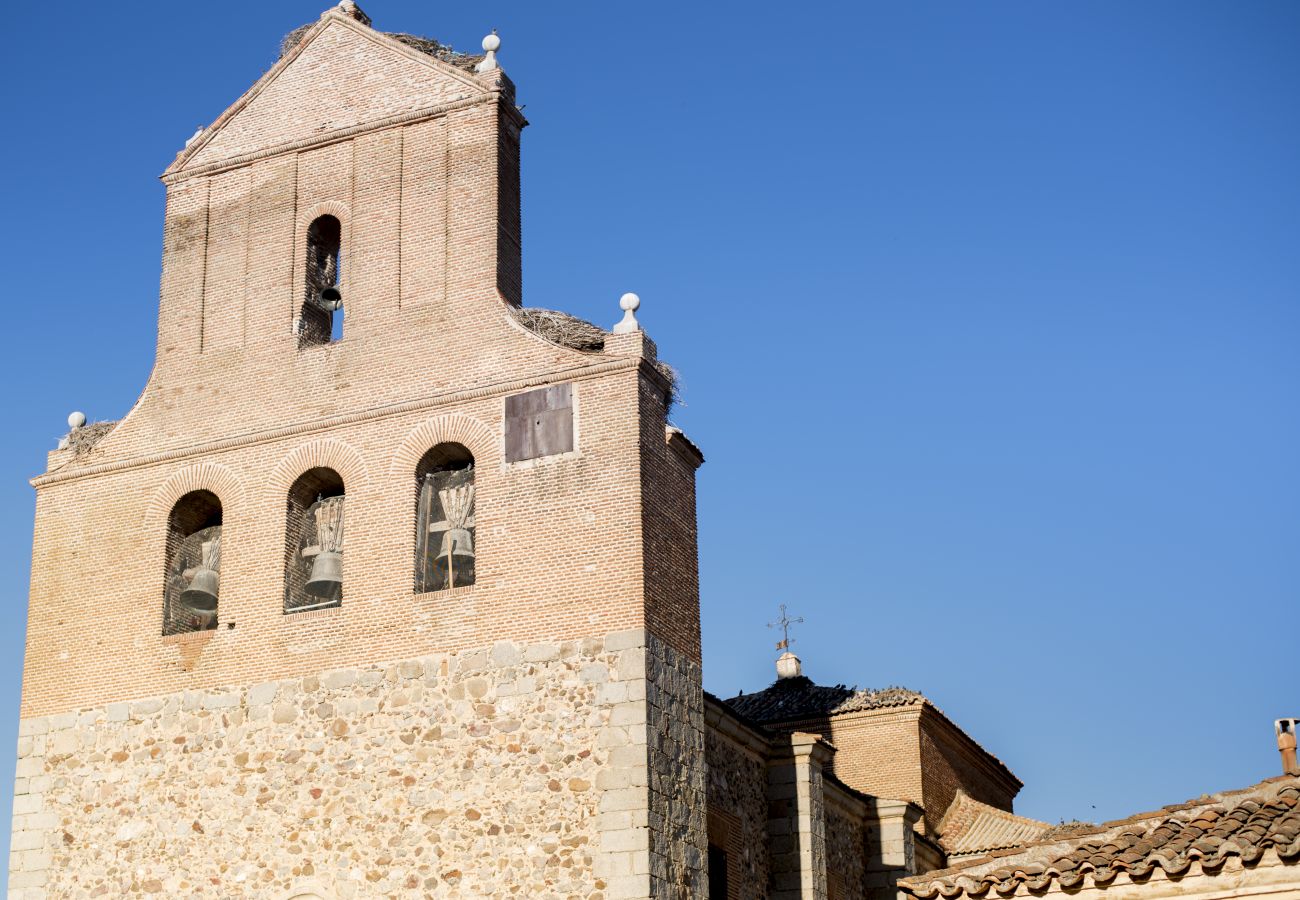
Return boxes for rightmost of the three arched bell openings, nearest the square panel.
[415,443,477,593]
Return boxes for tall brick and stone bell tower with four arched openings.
[9,3,707,900]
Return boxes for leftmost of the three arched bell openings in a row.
[163,490,221,635]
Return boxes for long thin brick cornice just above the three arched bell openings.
[30,356,639,489]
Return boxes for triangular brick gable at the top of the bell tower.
[164,10,491,176]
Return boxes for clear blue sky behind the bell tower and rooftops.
[0,0,1300,858]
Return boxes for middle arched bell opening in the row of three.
[285,467,343,613]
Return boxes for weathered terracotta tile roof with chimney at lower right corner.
[898,775,1300,900]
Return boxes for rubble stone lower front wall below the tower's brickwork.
[9,629,660,900]
